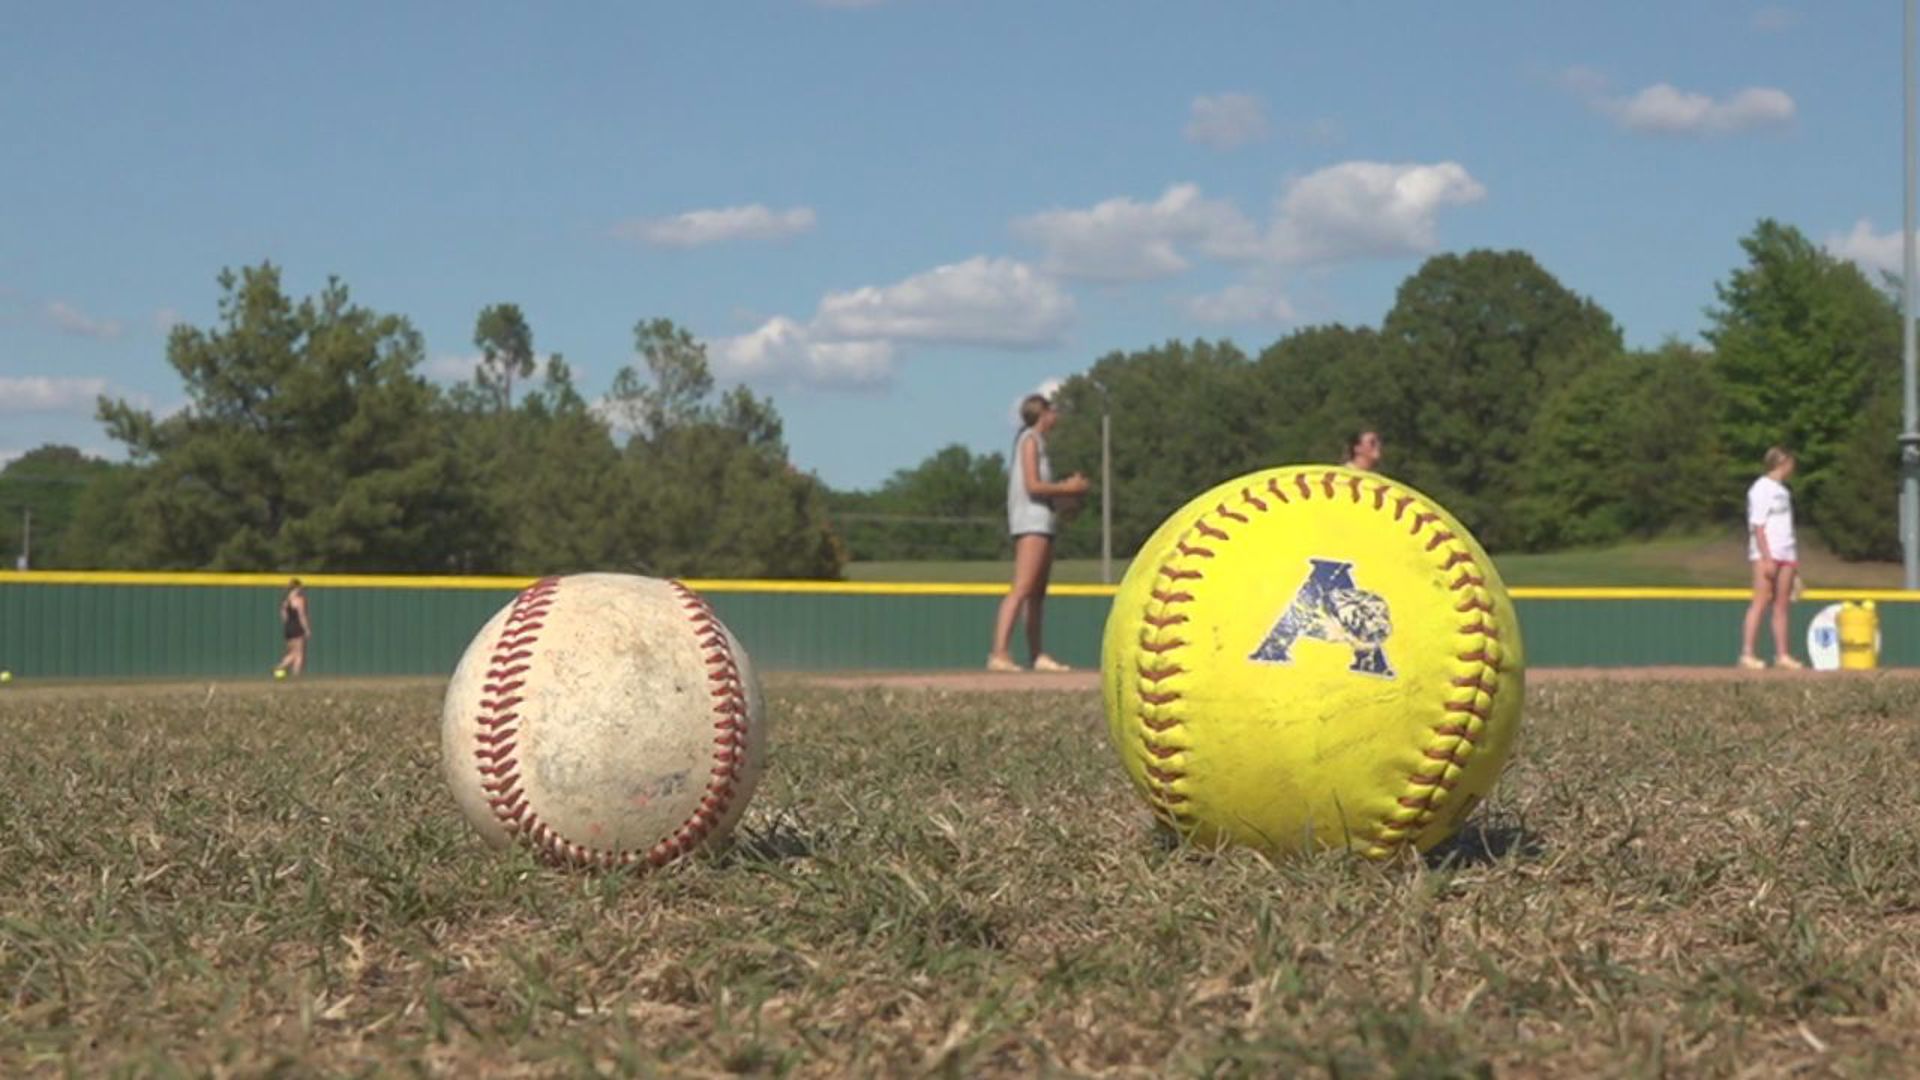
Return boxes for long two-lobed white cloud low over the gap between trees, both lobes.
[707,256,1075,388]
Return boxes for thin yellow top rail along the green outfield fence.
[0,571,1920,603]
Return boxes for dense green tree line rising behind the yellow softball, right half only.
[852,221,1901,559]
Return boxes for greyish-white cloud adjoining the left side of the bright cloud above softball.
[1014,184,1260,281]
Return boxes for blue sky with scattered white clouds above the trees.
[0,0,1901,486]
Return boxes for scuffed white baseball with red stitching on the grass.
[440,575,766,867]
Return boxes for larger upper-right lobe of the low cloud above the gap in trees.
[812,256,1073,348]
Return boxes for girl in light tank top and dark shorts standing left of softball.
[987,394,1089,671]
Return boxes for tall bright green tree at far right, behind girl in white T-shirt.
[1707,221,1901,550]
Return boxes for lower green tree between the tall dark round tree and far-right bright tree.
[1515,344,1738,550]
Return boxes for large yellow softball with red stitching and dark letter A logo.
[1102,465,1524,859]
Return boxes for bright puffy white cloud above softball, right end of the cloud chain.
[1267,161,1486,263]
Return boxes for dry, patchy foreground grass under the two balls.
[0,678,1920,1076]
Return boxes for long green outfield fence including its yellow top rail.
[0,571,1920,678]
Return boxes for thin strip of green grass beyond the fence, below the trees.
[847,536,1901,588]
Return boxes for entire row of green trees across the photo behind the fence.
[0,221,1901,578]
